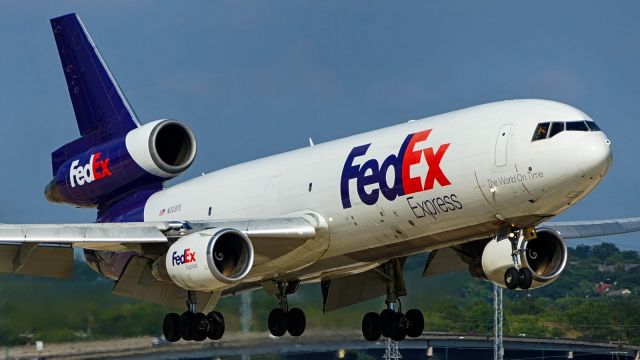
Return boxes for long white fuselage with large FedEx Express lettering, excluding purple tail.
[144,100,611,282]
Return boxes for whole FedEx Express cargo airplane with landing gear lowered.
[0,14,640,342]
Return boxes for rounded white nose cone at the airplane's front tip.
[573,132,612,178]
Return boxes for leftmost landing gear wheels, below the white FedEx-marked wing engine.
[162,290,225,342]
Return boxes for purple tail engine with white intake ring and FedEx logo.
[45,120,196,207]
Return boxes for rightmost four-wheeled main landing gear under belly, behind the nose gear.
[362,259,424,341]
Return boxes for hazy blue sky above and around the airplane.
[0,0,640,248]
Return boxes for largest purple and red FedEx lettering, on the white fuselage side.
[340,129,451,209]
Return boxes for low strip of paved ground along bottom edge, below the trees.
[0,331,638,360]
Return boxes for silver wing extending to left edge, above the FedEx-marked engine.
[0,216,316,277]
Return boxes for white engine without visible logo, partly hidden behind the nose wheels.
[470,229,567,289]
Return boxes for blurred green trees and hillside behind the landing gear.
[0,244,640,345]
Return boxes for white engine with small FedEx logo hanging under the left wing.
[161,228,253,291]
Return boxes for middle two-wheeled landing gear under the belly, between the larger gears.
[267,281,307,337]
